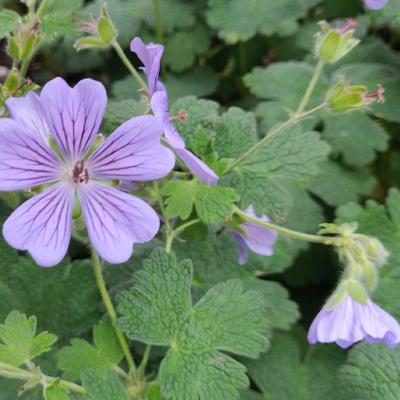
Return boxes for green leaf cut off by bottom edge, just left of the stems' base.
[82,370,129,400]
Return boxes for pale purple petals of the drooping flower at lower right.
[308,294,400,349]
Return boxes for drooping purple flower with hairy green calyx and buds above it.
[308,223,400,348]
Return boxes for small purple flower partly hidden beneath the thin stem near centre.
[232,206,278,265]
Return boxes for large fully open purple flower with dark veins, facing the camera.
[0,78,174,267]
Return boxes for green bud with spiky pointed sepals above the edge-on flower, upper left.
[74,6,118,51]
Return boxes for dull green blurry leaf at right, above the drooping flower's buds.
[310,162,376,206]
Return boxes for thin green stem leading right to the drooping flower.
[233,207,342,246]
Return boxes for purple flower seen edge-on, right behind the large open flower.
[131,37,218,185]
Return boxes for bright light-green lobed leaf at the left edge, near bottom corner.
[0,311,57,366]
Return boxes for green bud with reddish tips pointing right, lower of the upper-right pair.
[326,77,385,112]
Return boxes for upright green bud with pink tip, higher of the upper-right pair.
[316,19,360,63]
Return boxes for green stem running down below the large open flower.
[92,249,136,374]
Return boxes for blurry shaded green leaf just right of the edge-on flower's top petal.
[164,25,210,72]
